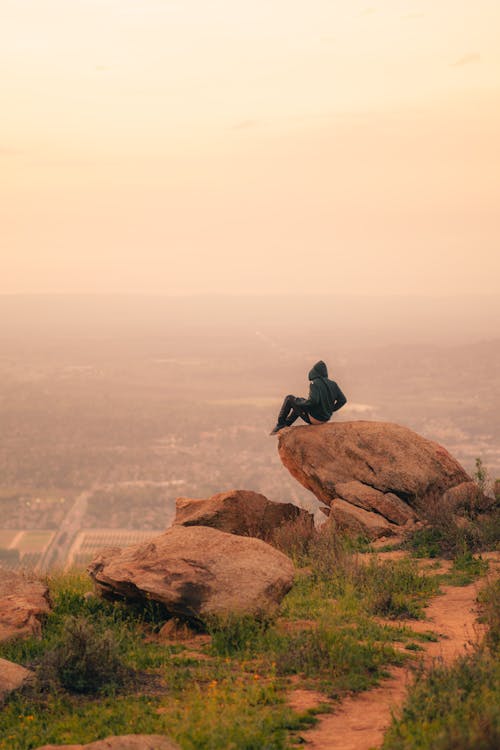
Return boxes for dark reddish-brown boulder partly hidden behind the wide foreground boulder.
[174,490,314,541]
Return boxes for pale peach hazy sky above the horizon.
[0,0,500,294]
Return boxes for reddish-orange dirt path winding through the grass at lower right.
[290,568,494,750]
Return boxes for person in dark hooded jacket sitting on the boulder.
[269,359,347,435]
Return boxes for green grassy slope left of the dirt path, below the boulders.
[0,535,484,750]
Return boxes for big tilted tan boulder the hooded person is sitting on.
[278,421,477,538]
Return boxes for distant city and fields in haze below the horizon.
[0,298,500,570]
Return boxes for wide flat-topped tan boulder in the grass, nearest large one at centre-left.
[88,526,294,620]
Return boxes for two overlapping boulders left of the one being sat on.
[88,490,306,621]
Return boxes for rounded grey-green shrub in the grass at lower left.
[38,616,129,693]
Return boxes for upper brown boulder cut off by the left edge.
[0,568,50,642]
